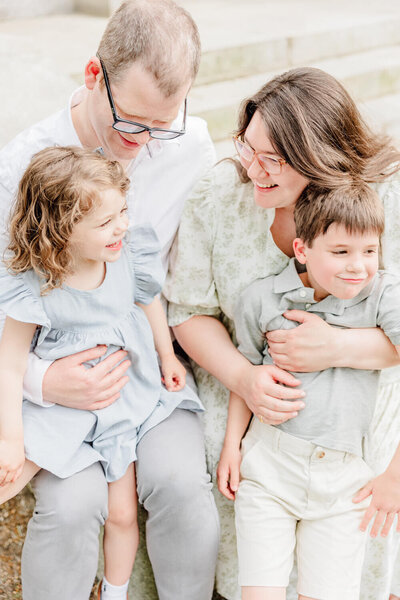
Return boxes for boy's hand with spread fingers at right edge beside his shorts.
[353,470,400,537]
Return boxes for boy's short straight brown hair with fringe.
[294,181,385,247]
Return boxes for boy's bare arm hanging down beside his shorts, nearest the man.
[217,392,252,500]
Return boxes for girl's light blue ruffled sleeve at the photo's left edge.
[0,266,50,339]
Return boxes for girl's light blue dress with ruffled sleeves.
[0,226,202,481]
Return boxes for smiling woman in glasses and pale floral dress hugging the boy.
[165,68,400,600]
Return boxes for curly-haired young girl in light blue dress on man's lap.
[0,147,202,600]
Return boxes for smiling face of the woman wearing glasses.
[244,110,308,208]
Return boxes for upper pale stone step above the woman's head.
[195,14,400,86]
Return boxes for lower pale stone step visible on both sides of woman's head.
[189,45,400,140]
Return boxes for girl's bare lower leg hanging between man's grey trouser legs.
[103,464,139,585]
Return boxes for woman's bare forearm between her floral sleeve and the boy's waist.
[173,315,251,396]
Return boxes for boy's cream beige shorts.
[235,419,373,600]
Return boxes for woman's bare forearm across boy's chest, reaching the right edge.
[332,328,400,369]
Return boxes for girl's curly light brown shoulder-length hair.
[6,146,130,293]
